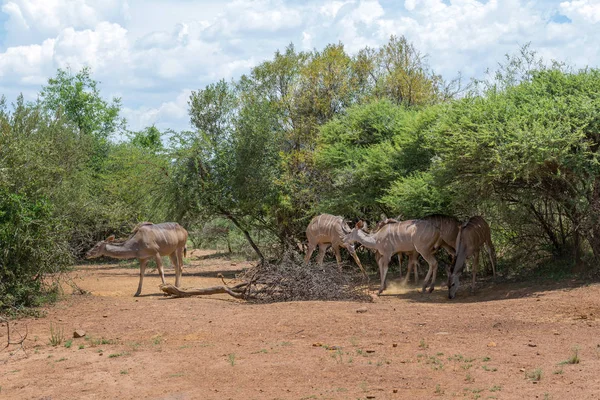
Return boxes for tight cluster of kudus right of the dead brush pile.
[304,214,496,299]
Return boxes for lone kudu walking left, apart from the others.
[85,222,188,297]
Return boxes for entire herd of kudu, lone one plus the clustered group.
[86,214,496,299]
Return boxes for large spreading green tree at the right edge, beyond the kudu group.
[430,68,600,266]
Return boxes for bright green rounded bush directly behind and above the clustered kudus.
[316,100,441,218]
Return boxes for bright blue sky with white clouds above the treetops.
[0,0,600,130]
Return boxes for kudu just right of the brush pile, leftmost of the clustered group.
[304,214,368,279]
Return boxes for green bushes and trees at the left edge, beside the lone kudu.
[0,69,168,309]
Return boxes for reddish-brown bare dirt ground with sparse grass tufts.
[0,250,600,400]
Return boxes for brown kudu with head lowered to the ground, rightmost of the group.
[448,216,496,299]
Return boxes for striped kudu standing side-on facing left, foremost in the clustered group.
[344,220,441,294]
